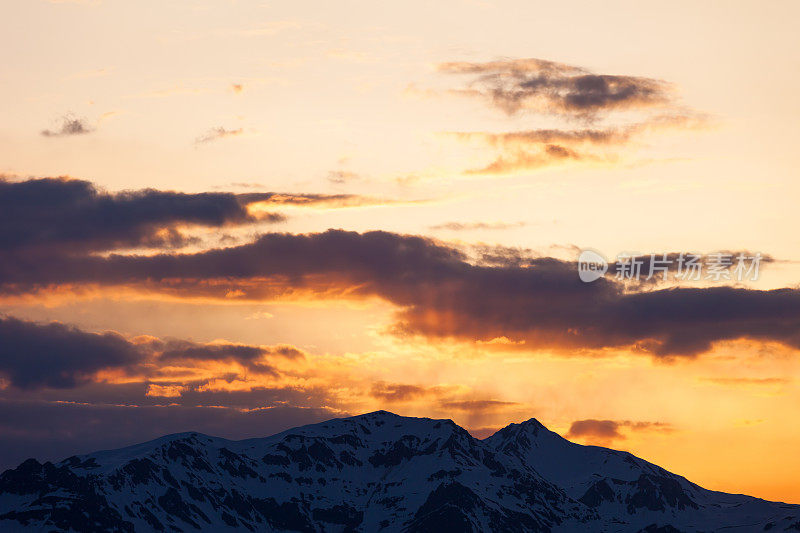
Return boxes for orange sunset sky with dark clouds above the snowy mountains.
[0,0,800,503]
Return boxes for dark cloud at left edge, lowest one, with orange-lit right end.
[0,317,305,388]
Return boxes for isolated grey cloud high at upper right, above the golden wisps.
[439,59,671,118]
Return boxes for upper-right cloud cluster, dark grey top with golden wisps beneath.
[438,59,710,175]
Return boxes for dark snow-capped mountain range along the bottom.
[0,411,800,532]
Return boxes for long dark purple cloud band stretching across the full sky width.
[0,230,800,356]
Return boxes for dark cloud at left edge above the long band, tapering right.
[0,176,388,253]
